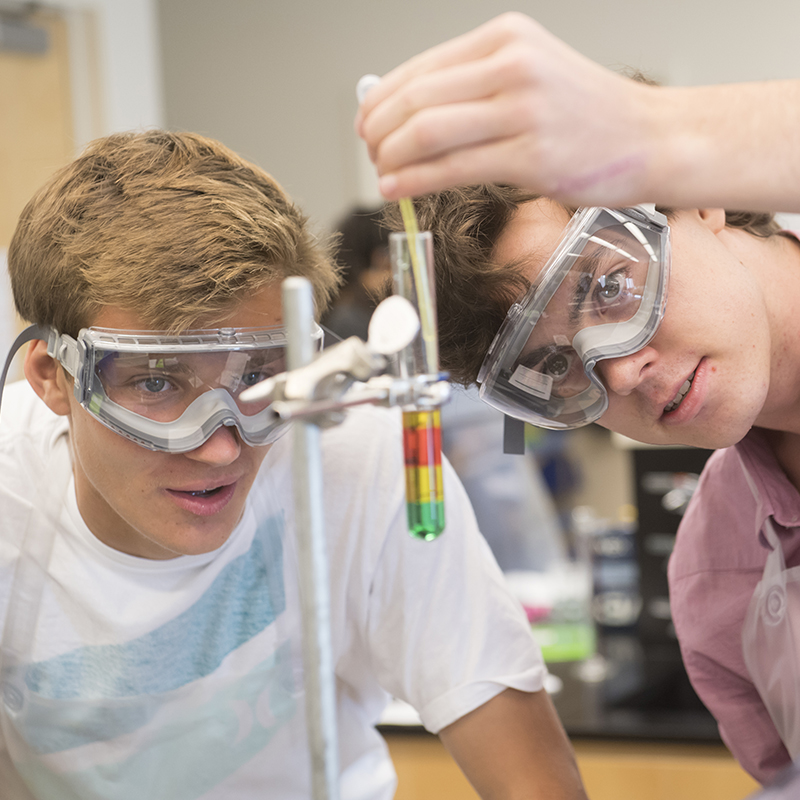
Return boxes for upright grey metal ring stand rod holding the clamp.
[282,277,339,800]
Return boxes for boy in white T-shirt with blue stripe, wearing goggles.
[0,131,584,800]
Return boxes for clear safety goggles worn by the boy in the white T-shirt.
[0,326,322,453]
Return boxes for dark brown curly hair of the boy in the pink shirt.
[385,185,780,386]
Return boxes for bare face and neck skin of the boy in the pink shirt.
[494,199,800,448]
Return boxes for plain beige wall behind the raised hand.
[157,0,800,231]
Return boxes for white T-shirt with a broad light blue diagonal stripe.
[0,383,545,800]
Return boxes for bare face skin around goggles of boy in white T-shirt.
[25,286,281,559]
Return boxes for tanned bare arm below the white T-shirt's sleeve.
[439,689,586,800]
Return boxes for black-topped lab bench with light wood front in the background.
[381,634,758,800]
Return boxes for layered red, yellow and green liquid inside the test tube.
[403,408,444,541]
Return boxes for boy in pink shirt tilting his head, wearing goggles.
[384,185,800,782]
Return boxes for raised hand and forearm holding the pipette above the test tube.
[356,13,800,211]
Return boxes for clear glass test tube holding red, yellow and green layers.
[389,231,445,541]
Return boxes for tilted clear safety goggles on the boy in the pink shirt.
[478,206,670,429]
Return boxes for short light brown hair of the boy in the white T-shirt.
[8,130,339,336]
